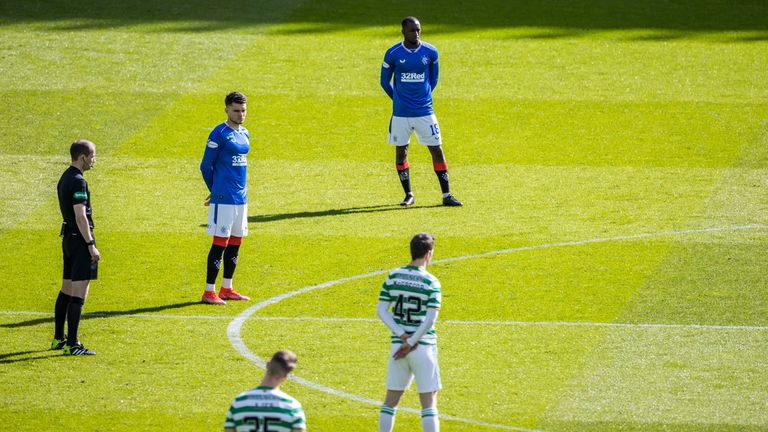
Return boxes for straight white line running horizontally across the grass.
[0,311,768,330]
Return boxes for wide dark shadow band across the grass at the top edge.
[0,0,768,36]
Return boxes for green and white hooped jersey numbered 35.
[224,386,307,432]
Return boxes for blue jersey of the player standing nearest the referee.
[200,122,251,204]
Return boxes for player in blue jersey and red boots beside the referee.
[200,92,251,304]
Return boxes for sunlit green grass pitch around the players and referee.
[0,0,768,432]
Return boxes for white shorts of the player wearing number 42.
[387,344,443,393]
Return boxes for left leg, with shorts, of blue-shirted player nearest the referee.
[200,204,233,304]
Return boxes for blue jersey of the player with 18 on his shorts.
[381,41,440,117]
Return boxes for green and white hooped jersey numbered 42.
[379,265,442,345]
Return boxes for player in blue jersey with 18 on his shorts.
[381,16,461,206]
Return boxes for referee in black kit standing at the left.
[51,139,101,355]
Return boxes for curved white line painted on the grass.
[227,225,768,432]
